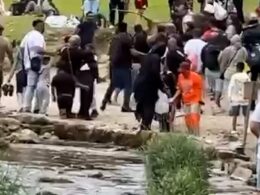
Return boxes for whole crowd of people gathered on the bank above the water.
[0,0,260,135]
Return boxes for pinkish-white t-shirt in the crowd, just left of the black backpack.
[184,38,207,72]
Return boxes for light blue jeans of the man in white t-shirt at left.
[23,70,39,112]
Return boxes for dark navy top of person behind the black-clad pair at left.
[78,21,97,48]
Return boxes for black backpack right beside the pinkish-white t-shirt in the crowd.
[201,43,221,71]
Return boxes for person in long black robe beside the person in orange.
[134,42,166,130]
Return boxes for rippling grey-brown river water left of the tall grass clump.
[1,142,146,195]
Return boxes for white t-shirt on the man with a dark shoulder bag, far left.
[20,30,46,69]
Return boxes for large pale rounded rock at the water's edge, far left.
[9,129,39,144]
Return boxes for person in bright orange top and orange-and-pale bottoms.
[173,61,203,136]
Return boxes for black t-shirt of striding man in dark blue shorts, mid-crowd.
[110,33,133,68]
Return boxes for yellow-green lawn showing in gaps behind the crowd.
[1,0,257,39]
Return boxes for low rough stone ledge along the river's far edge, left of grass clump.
[0,114,153,148]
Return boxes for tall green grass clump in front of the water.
[145,135,209,195]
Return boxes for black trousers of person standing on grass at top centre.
[109,0,125,25]
